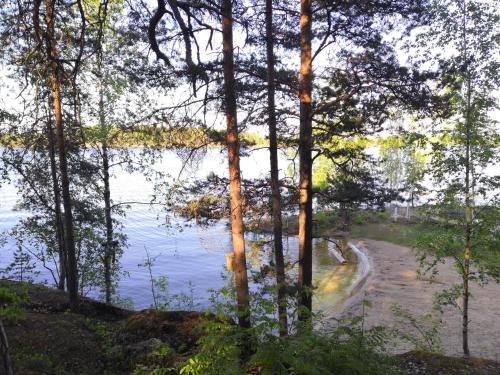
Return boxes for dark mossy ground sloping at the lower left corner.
[0,280,202,375]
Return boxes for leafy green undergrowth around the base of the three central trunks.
[180,282,395,375]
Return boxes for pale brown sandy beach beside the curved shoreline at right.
[344,240,500,361]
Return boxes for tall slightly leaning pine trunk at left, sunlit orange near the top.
[45,0,78,310]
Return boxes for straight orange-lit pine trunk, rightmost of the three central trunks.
[298,0,312,320]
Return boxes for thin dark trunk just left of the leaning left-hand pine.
[47,111,67,290]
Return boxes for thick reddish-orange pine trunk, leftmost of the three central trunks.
[221,0,250,328]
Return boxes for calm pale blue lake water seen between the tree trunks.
[0,149,357,315]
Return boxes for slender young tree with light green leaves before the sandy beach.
[410,0,500,355]
